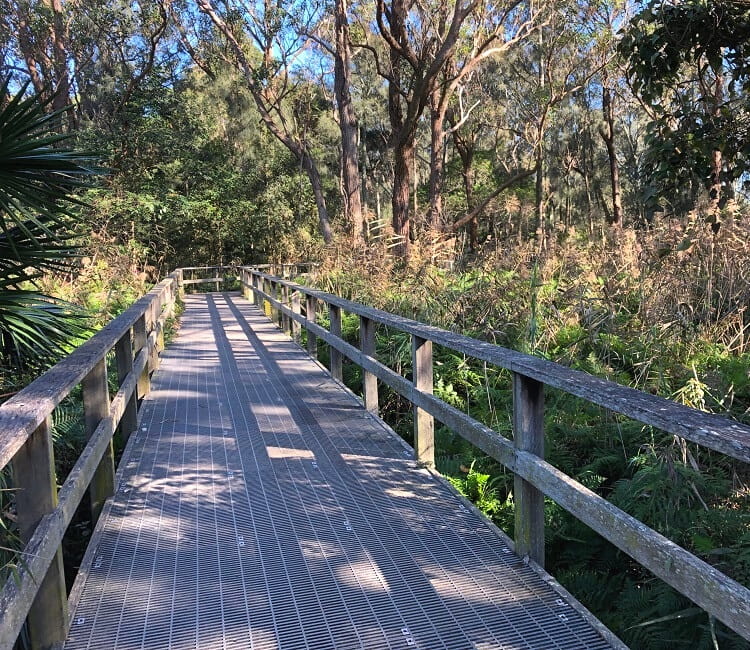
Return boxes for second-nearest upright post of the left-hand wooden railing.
[81,358,115,524]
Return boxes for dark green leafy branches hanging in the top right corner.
[619,0,750,218]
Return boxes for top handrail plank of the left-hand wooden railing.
[0,273,177,469]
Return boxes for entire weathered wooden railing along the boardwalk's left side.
[0,270,182,649]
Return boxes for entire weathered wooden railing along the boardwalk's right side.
[239,267,750,640]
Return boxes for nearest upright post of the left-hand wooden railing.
[13,417,68,650]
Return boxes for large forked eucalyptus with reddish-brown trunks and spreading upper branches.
[360,0,532,256]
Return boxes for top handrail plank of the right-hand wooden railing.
[248,274,750,463]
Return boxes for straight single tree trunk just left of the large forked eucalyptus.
[334,0,364,241]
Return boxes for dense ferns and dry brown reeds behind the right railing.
[308,225,750,648]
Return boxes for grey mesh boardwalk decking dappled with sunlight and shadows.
[65,293,624,650]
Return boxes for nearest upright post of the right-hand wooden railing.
[513,372,544,567]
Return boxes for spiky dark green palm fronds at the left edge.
[0,79,91,369]
